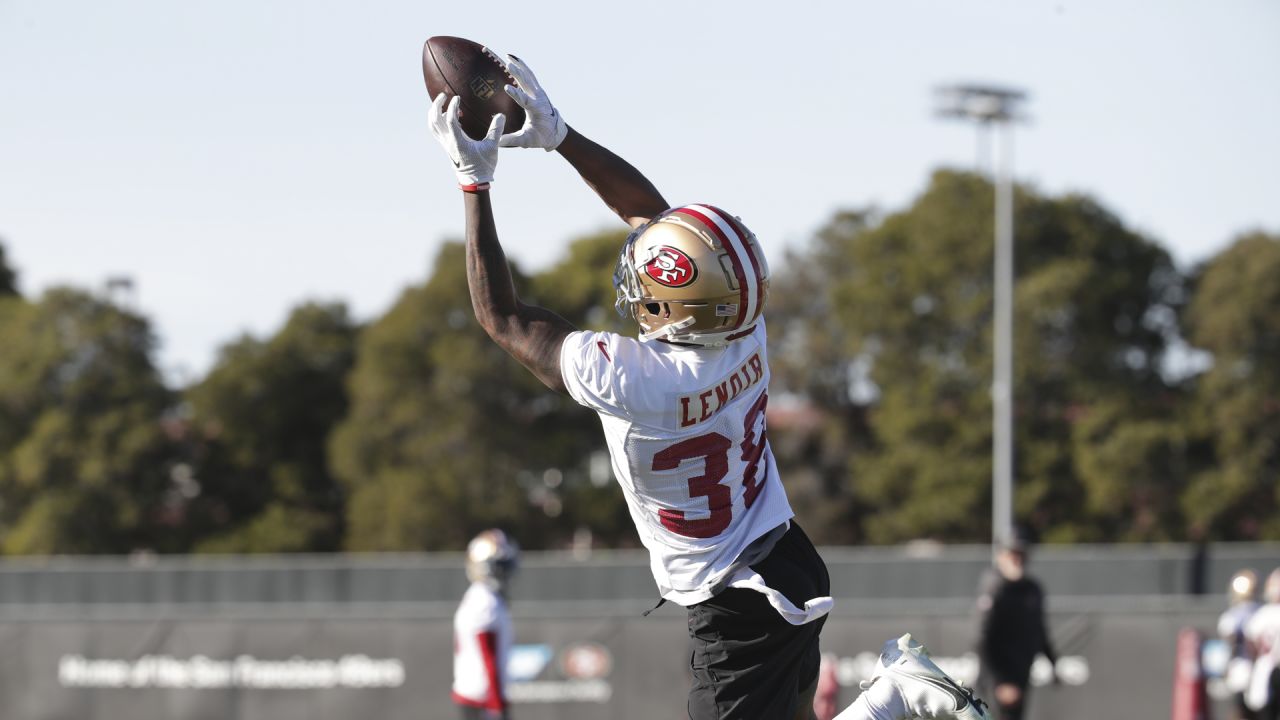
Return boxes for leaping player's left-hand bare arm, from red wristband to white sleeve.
[463,191,575,392]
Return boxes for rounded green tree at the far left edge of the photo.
[0,288,177,553]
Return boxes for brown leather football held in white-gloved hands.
[422,35,525,140]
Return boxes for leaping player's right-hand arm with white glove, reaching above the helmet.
[499,55,669,227]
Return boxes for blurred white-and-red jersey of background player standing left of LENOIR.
[453,583,512,708]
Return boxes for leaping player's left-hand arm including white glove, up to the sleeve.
[430,94,576,392]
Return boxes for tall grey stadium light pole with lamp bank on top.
[937,85,1027,544]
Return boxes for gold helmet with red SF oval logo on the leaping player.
[613,205,769,346]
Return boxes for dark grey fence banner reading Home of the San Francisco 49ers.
[0,606,1213,720]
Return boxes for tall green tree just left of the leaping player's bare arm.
[330,243,560,551]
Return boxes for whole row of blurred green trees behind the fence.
[0,170,1280,555]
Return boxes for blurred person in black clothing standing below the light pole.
[978,528,1057,720]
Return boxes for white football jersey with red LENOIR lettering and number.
[561,320,792,606]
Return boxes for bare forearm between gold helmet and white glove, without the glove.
[556,127,669,227]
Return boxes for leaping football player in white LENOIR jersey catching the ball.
[430,51,986,720]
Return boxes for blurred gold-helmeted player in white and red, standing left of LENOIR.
[453,529,520,720]
